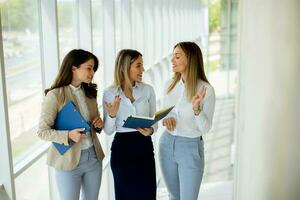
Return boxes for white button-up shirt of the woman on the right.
[164,80,215,138]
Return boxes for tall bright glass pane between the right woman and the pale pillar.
[202,0,237,186]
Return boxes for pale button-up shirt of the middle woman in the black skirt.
[103,82,157,135]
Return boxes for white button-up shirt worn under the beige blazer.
[70,84,93,150]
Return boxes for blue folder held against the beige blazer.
[52,101,91,155]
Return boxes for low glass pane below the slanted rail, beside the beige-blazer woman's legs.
[15,155,50,200]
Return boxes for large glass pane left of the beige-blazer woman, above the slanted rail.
[1,0,42,162]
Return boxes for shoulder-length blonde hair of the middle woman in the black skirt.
[114,49,143,91]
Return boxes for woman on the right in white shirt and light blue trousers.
[159,42,215,200]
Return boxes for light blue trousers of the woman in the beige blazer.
[55,147,102,200]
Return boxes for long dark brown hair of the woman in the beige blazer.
[45,49,99,98]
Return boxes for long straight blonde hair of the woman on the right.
[167,42,209,101]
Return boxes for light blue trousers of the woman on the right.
[159,132,204,200]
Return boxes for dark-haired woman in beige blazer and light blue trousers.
[38,49,104,200]
